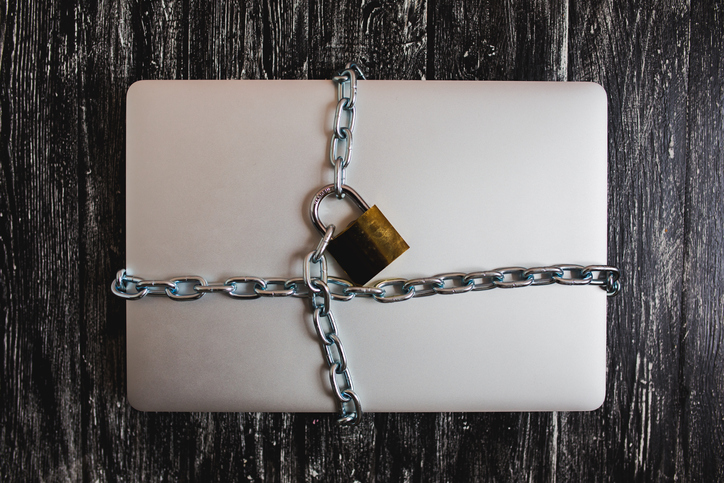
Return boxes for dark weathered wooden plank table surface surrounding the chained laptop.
[0,0,724,482]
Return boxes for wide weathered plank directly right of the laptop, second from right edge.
[559,1,689,481]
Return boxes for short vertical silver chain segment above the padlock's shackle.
[329,63,365,199]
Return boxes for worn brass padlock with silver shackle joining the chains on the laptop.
[310,184,410,285]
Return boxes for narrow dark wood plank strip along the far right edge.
[680,2,724,481]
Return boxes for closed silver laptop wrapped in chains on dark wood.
[126,80,607,412]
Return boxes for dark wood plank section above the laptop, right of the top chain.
[428,0,569,81]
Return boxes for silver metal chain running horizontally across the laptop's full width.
[111,264,621,303]
